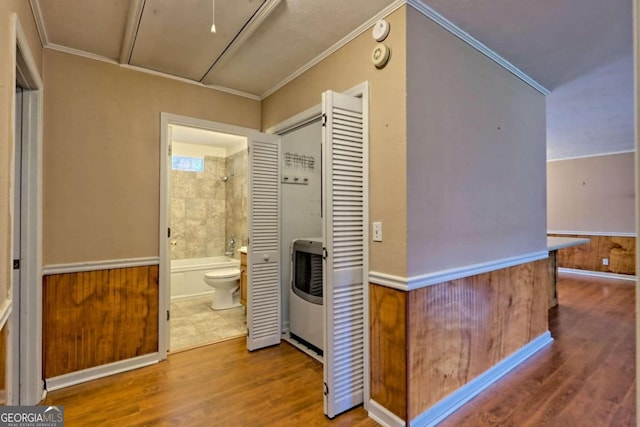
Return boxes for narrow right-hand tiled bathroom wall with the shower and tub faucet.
[226,150,249,258]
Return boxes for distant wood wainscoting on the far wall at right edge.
[549,234,636,275]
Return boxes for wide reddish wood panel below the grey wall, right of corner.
[408,259,549,419]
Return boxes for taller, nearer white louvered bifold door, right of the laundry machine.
[322,91,366,418]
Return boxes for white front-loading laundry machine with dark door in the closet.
[289,237,324,355]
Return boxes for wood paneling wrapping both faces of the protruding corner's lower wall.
[370,259,549,422]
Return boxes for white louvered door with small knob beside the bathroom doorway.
[247,132,281,350]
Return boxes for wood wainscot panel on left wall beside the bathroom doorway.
[43,265,158,378]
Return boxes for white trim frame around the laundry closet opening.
[265,81,371,411]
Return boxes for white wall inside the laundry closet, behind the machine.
[280,120,322,323]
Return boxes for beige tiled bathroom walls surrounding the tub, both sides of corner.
[170,154,249,259]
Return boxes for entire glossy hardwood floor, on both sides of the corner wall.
[42,274,636,427]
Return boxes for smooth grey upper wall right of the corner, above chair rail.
[407,8,546,277]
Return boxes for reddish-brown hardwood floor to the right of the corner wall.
[440,274,636,427]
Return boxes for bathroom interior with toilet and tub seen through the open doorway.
[169,125,248,352]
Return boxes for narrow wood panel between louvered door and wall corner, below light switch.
[369,284,408,420]
